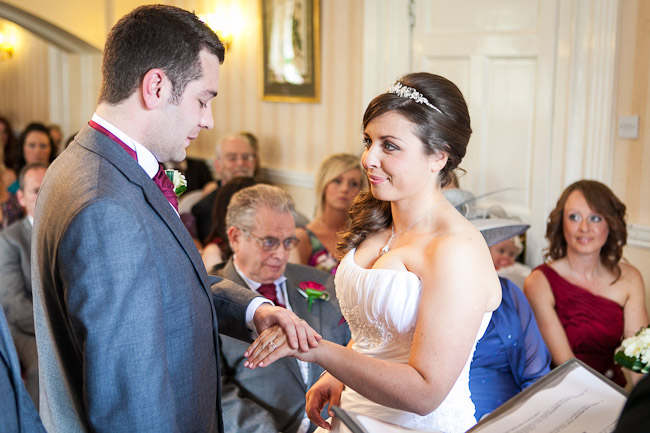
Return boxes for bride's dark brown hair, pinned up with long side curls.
[338,72,472,256]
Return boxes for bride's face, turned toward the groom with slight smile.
[361,112,446,201]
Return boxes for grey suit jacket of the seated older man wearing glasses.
[218,259,350,433]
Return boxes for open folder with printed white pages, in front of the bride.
[333,358,627,433]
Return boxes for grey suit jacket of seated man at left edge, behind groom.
[0,218,34,338]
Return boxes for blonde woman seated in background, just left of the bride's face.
[289,153,366,274]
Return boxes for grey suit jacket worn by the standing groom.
[32,127,252,433]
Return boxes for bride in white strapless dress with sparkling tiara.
[247,73,501,433]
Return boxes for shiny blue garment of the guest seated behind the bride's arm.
[469,278,551,420]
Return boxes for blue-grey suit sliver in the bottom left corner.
[0,311,45,433]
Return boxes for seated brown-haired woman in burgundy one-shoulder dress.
[524,180,648,386]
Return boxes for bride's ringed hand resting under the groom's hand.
[244,325,316,369]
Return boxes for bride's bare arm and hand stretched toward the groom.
[249,237,501,415]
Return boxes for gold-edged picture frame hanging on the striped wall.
[260,0,320,103]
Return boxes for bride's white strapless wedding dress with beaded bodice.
[316,249,492,433]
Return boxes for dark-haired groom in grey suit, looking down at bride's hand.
[32,5,318,433]
